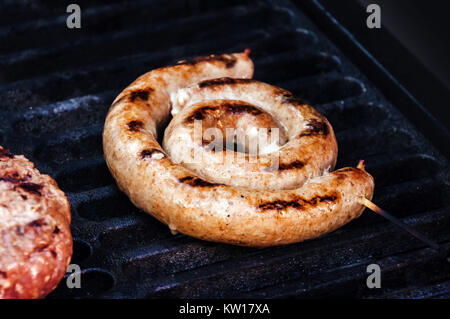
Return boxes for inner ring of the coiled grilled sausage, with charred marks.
[163,78,337,190]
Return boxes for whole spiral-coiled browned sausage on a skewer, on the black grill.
[103,52,374,247]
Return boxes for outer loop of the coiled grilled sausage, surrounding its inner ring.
[103,54,374,247]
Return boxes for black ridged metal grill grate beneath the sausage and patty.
[0,0,450,298]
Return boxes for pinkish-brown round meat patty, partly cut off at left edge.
[0,146,72,299]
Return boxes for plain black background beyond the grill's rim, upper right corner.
[319,0,450,134]
